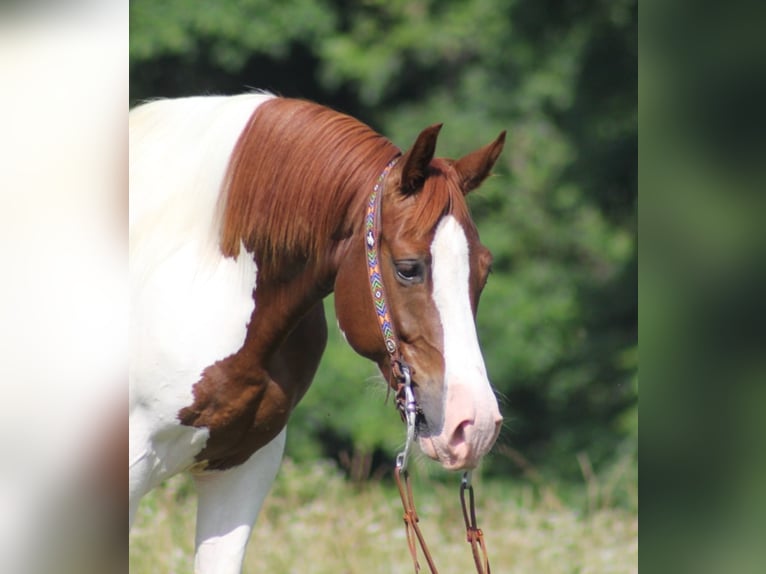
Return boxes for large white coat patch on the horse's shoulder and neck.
[129,94,271,510]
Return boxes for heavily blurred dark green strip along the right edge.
[639,0,766,573]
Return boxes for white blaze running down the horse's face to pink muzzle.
[421,215,502,469]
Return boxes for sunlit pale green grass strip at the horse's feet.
[130,460,638,574]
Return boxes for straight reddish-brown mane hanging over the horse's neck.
[220,98,399,270]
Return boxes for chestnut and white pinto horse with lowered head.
[129,92,505,574]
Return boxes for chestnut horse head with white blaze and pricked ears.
[335,125,505,470]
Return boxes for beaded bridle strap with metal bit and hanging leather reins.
[364,157,490,574]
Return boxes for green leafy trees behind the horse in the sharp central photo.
[130,0,638,486]
